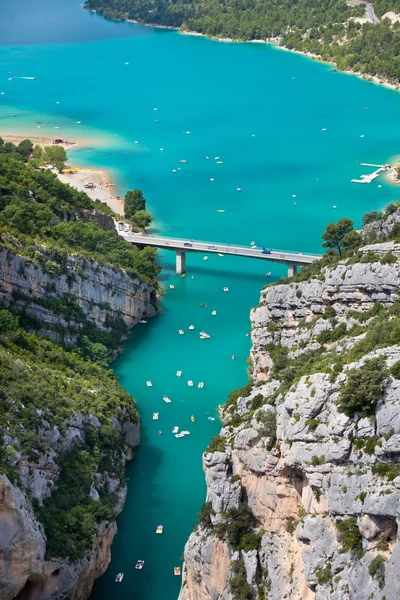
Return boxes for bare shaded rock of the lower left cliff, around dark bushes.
[0,414,140,600]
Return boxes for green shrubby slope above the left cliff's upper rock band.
[0,138,160,287]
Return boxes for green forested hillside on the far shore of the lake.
[85,0,400,85]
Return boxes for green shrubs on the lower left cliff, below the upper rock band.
[0,309,138,560]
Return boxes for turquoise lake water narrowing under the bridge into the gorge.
[0,0,400,600]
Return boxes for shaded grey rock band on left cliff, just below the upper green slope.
[0,244,156,346]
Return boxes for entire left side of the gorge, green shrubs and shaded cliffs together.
[0,138,159,600]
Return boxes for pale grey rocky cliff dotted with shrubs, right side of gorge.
[179,239,400,600]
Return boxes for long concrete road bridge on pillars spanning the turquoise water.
[118,231,322,277]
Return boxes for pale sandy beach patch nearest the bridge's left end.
[58,165,124,215]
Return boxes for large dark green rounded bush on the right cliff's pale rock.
[338,358,389,418]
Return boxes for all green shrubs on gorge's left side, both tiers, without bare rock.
[0,138,160,560]
